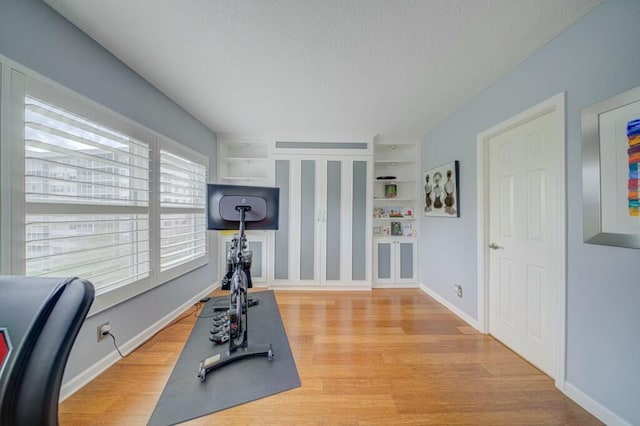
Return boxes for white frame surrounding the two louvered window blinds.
[0,55,215,316]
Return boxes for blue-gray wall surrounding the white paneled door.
[419,0,640,424]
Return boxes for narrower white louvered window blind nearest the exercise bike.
[160,149,207,272]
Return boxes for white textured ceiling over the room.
[45,0,600,140]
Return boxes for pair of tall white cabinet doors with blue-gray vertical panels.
[273,157,371,288]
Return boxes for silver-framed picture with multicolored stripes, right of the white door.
[581,86,640,249]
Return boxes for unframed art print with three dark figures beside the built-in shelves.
[422,160,460,217]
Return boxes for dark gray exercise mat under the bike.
[148,291,300,426]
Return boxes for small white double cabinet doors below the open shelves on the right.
[373,238,417,287]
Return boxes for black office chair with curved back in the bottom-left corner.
[0,276,95,426]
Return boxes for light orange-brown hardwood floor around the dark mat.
[59,289,601,426]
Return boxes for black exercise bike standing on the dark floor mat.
[198,185,274,381]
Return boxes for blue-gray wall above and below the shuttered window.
[0,0,217,380]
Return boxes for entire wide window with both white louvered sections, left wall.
[0,64,209,313]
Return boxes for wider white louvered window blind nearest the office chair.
[24,96,150,290]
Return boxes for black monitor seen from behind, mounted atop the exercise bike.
[207,183,280,231]
